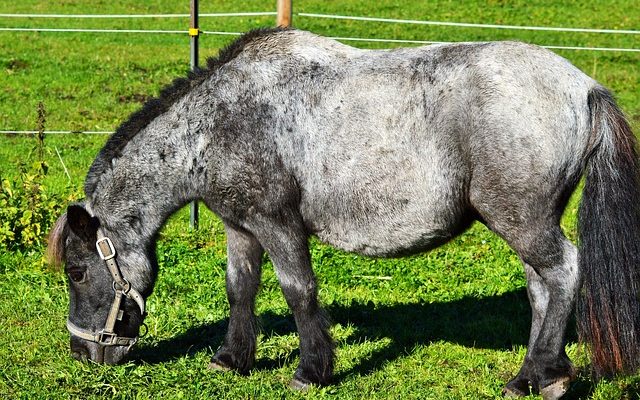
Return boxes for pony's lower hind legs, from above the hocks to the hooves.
[498,227,579,400]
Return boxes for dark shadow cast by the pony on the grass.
[131,289,593,399]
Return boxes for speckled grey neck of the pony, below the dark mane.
[87,114,202,247]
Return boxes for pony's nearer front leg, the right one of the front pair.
[254,214,335,389]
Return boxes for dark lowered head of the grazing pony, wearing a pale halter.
[47,204,152,364]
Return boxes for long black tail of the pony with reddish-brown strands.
[577,87,640,378]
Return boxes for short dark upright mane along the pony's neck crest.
[84,27,288,196]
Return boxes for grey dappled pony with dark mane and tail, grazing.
[49,29,640,400]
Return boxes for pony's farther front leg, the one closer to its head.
[209,225,263,374]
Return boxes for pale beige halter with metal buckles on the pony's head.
[67,230,144,347]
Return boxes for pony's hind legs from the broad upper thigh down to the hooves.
[469,149,580,400]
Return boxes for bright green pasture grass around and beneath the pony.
[0,0,640,399]
